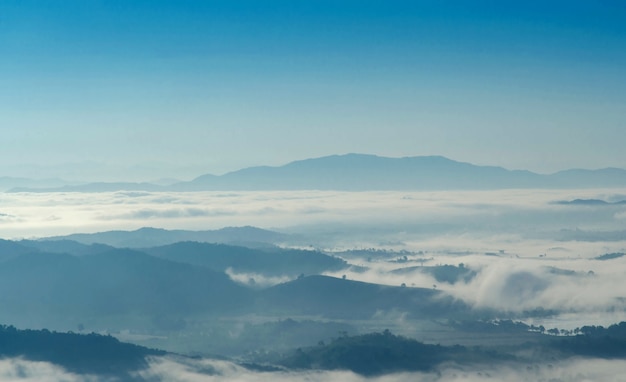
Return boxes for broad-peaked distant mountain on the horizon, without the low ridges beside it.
[174,154,544,191]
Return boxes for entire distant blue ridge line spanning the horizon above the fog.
[10,154,626,192]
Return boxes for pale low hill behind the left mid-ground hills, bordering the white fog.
[42,226,289,248]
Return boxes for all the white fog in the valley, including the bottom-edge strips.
[0,189,626,381]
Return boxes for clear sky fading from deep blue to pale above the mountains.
[0,0,626,176]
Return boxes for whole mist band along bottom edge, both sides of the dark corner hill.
[7,356,626,382]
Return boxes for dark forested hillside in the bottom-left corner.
[0,325,165,380]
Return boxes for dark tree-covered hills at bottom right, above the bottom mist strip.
[275,320,626,376]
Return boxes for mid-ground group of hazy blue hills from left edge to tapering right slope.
[0,241,468,330]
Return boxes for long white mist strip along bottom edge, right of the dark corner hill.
[135,357,626,382]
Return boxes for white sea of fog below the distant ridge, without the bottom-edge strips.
[0,189,626,317]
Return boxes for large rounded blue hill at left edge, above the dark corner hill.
[0,249,252,328]
